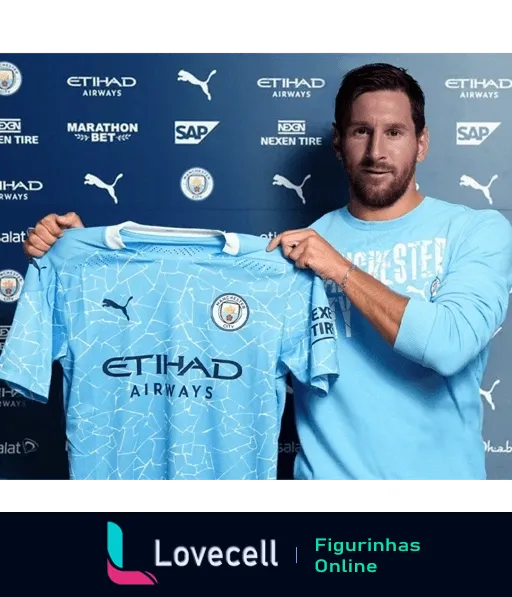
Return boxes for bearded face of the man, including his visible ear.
[338,91,427,208]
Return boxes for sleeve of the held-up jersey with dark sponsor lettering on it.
[281,270,339,396]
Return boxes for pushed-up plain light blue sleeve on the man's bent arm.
[394,210,512,377]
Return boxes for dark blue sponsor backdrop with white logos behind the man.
[0,53,512,479]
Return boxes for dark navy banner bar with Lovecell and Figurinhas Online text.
[0,508,508,595]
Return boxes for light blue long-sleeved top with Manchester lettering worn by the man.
[295,197,512,481]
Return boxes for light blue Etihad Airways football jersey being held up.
[0,222,338,481]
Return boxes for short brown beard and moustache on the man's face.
[347,158,416,208]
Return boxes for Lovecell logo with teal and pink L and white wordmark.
[107,522,278,585]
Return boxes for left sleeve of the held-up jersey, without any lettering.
[0,255,67,402]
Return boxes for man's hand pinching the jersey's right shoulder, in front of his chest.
[267,228,351,280]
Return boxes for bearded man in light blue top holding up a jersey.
[25,64,512,481]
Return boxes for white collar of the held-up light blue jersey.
[105,221,240,255]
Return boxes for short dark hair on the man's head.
[334,63,425,135]
